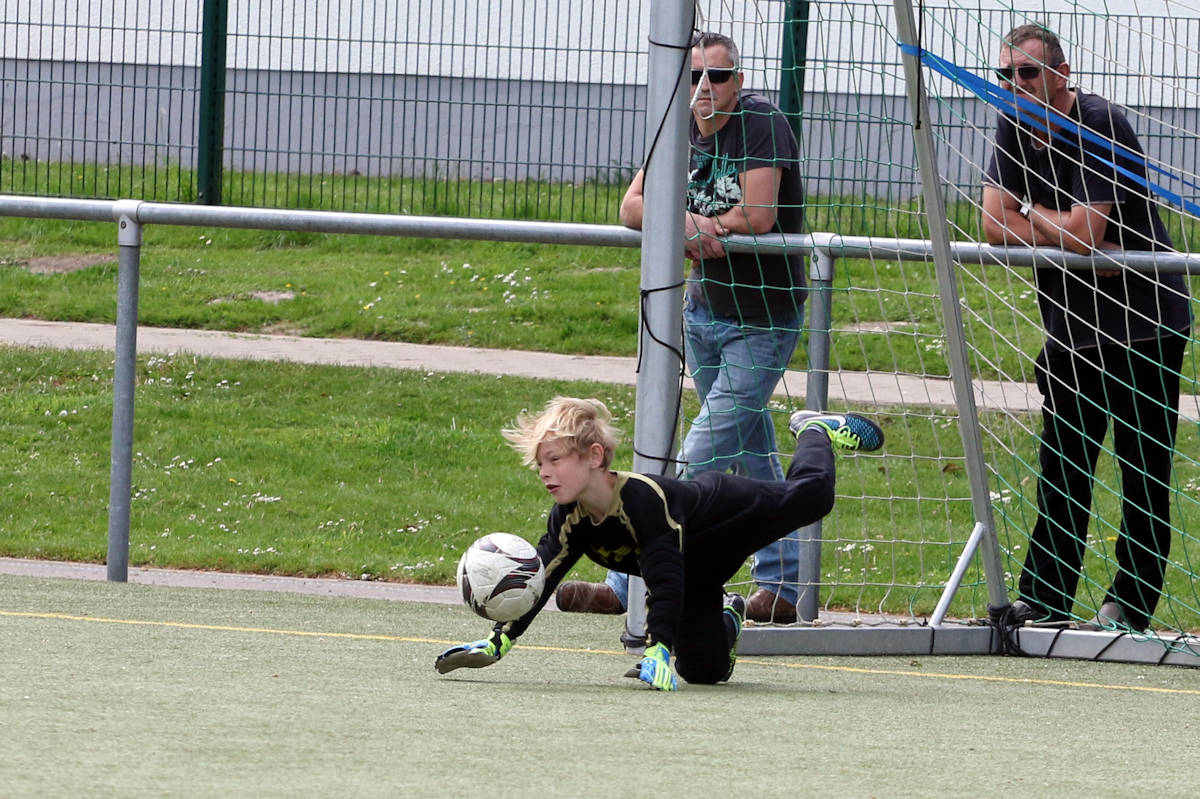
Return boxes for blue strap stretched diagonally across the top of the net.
[900,42,1200,216]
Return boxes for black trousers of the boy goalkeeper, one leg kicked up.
[674,429,835,685]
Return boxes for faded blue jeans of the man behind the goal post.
[605,298,804,605]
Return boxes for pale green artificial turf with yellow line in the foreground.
[0,576,1200,798]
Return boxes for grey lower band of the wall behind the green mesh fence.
[0,60,1200,200]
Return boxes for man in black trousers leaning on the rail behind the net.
[983,25,1192,631]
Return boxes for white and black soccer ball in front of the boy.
[458,533,546,621]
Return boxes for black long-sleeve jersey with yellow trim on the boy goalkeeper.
[496,471,704,649]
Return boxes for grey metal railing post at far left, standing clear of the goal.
[108,200,142,583]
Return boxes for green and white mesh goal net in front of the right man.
[684,0,1200,649]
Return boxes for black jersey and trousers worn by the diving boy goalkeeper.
[494,427,836,684]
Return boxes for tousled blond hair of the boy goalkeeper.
[500,397,619,469]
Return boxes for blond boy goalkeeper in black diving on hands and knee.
[434,397,883,691]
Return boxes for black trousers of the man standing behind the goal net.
[1019,336,1187,630]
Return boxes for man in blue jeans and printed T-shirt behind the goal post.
[557,32,805,624]
